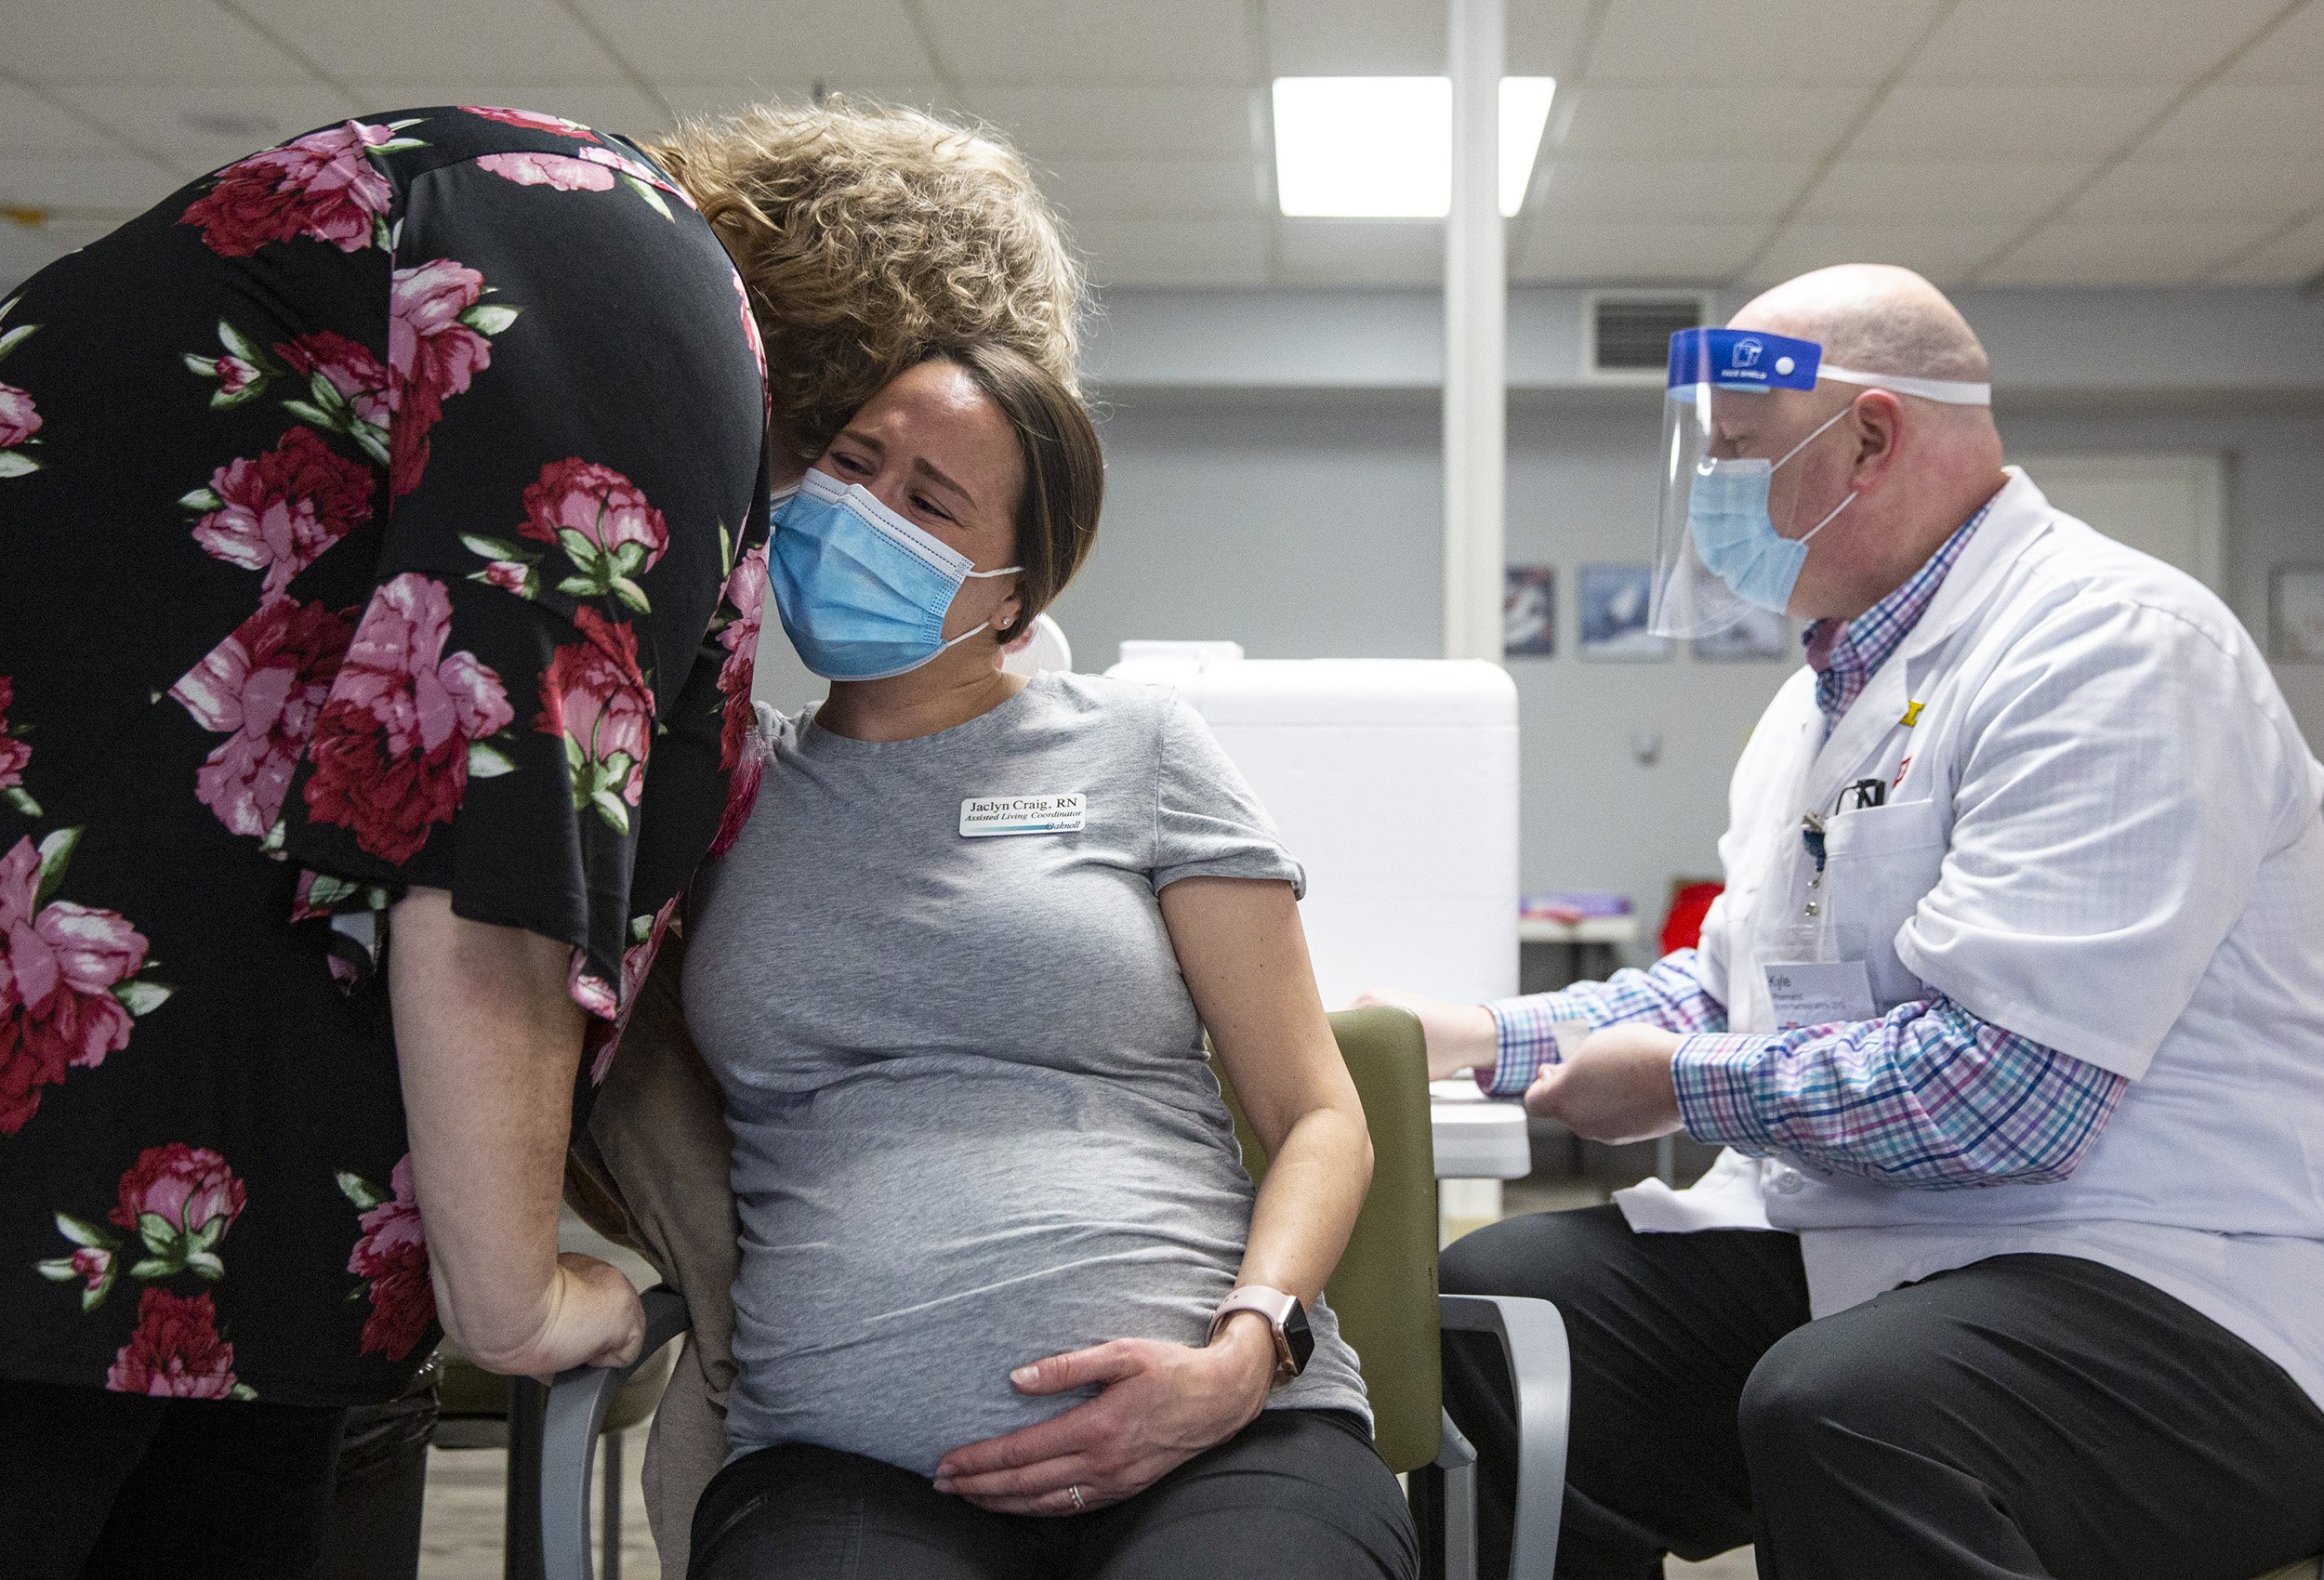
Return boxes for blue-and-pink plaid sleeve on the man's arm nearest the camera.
[1673,997,2132,1190]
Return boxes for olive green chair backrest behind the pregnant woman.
[1211,1008,1444,1473]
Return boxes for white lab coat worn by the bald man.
[1622,467,2324,1403]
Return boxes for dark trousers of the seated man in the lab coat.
[1422,1206,2324,1580]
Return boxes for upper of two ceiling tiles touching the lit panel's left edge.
[967,86,1260,165]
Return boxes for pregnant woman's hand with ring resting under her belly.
[937,1315,1276,1515]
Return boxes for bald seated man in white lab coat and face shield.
[1367,265,2324,1580]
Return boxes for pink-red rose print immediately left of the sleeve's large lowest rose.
[170,598,356,839]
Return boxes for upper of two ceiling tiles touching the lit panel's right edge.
[1557,82,1867,161]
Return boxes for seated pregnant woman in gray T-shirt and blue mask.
[683,351,1416,1580]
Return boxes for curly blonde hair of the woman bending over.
[646,98,1083,460]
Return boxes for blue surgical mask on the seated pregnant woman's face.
[767,472,1023,681]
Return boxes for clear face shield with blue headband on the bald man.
[1648,330,1992,637]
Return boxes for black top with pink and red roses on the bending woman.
[0,107,767,1403]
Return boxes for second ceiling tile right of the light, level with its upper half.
[1848,77,2178,161]
